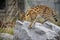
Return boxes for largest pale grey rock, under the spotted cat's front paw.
[14,20,60,40]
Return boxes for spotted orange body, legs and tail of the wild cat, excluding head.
[25,5,57,28]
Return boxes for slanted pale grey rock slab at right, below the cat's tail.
[43,21,60,38]
